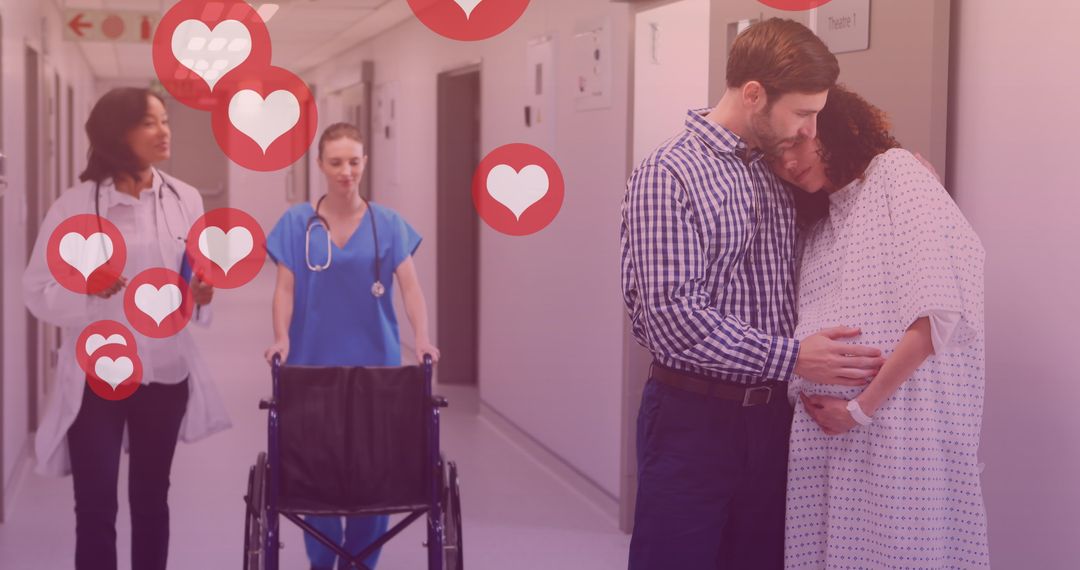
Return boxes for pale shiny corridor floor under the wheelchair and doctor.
[0,272,630,570]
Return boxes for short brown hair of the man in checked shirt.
[727,17,840,107]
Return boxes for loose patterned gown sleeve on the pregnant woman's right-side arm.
[867,150,985,353]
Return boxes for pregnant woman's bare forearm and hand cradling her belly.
[799,316,934,435]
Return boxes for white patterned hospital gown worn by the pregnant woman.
[785,149,989,569]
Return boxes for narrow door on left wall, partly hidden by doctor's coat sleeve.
[24,46,44,432]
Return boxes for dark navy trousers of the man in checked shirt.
[630,379,793,570]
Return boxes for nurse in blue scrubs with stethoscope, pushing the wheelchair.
[266,123,438,570]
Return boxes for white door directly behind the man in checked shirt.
[619,0,715,532]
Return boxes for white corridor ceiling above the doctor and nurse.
[54,0,413,79]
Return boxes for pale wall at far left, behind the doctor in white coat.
[0,0,95,507]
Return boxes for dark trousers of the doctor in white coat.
[68,380,189,570]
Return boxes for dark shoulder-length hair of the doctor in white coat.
[79,87,165,182]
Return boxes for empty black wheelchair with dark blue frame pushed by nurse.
[243,355,464,570]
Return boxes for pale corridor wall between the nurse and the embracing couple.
[306,0,631,498]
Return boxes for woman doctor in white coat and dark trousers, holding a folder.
[23,89,230,570]
